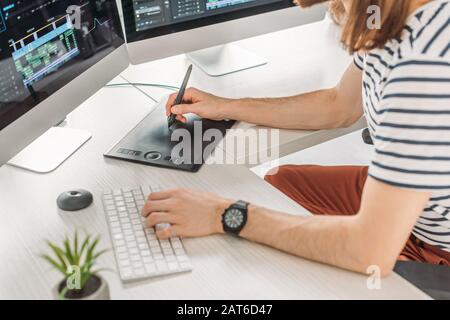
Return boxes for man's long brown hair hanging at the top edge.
[295,0,411,53]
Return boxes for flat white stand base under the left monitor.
[8,127,92,173]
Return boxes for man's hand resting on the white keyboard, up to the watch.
[142,189,233,239]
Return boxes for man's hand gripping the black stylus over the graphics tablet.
[166,88,232,122]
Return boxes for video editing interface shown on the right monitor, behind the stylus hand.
[128,0,280,32]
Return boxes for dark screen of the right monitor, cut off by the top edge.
[122,0,294,42]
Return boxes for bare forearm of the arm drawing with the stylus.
[224,89,356,130]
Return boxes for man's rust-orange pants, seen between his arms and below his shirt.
[265,165,450,266]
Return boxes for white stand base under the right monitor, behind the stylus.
[187,44,267,77]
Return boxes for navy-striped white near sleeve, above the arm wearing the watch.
[369,55,450,191]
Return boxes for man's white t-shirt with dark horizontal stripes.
[354,0,450,251]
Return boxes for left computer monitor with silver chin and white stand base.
[0,0,129,172]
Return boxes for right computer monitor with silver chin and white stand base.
[122,0,326,76]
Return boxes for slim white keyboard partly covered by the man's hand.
[103,186,192,282]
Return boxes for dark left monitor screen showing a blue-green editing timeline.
[0,0,124,130]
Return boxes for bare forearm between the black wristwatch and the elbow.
[241,206,375,273]
